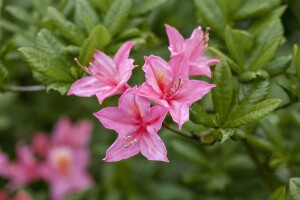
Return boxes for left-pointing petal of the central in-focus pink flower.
[134,82,169,107]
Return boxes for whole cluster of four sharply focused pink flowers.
[68,25,219,162]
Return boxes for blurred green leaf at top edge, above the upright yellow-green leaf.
[74,0,99,34]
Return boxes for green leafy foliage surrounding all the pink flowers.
[0,0,300,200]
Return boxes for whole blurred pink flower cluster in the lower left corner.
[0,118,92,200]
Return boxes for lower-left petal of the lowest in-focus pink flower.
[103,135,140,162]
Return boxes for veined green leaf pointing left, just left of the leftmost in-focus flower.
[19,47,73,82]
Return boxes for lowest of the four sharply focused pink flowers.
[94,87,169,162]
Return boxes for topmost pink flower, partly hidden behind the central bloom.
[165,24,220,78]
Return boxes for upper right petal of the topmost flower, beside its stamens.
[184,27,207,62]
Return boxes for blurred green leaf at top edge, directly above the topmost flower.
[194,0,227,38]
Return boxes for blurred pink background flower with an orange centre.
[40,146,92,200]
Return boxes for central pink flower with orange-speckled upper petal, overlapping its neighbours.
[135,54,215,129]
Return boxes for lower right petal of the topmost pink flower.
[189,56,220,78]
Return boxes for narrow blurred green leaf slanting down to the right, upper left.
[48,7,85,46]
